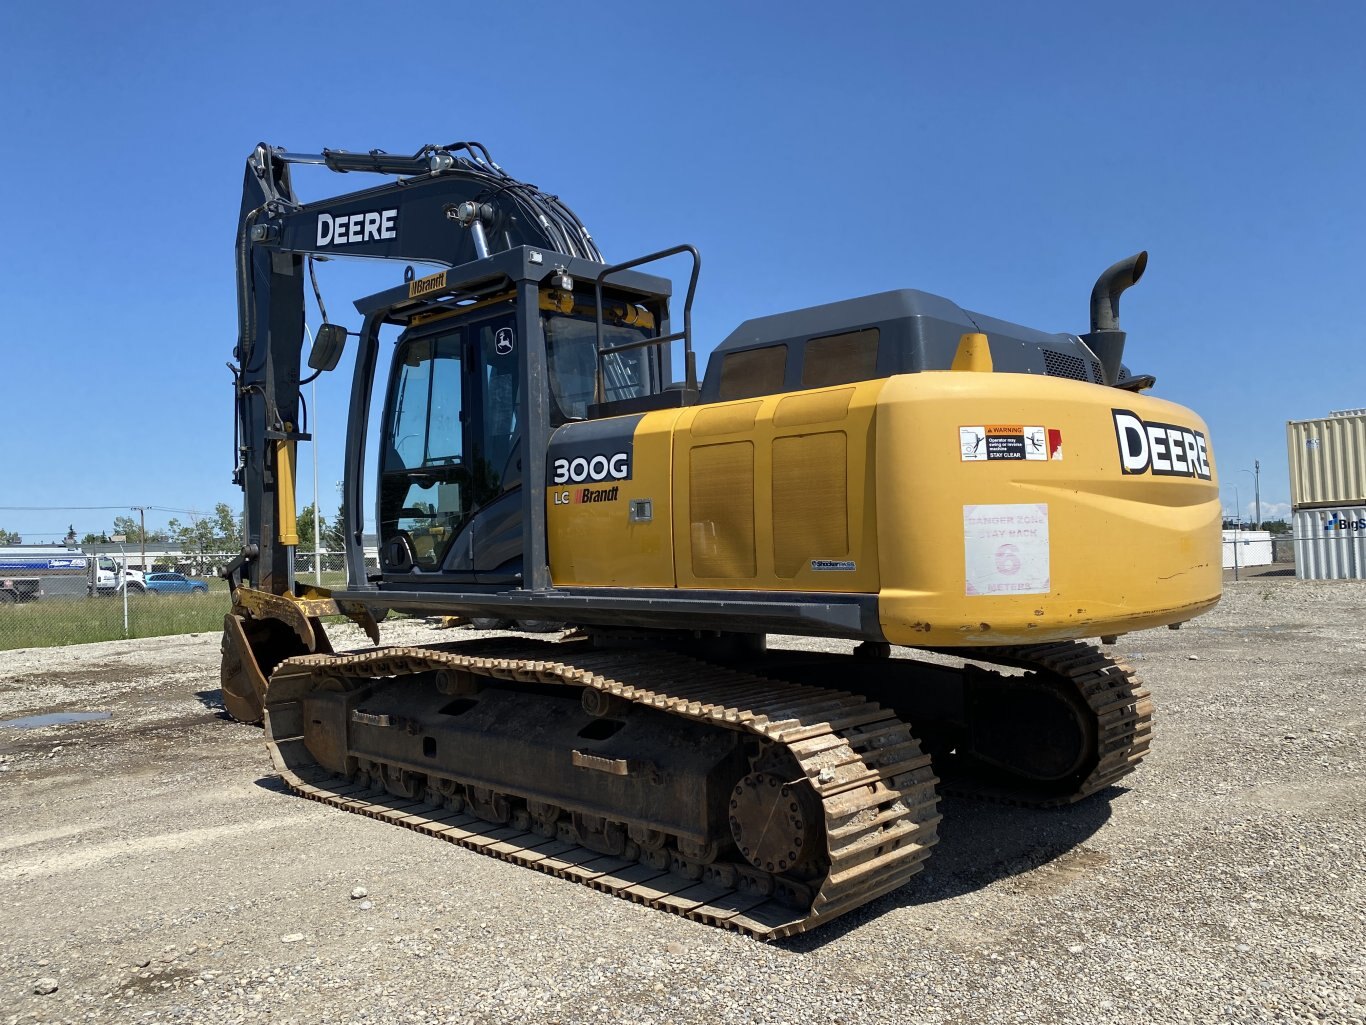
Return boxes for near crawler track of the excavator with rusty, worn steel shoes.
[266,641,941,939]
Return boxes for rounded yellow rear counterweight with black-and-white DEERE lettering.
[877,372,1221,646]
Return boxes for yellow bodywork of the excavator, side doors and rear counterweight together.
[546,372,1221,646]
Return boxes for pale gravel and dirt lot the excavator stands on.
[0,577,1366,1025]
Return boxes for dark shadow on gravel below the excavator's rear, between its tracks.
[775,786,1128,954]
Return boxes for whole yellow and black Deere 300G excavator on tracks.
[223,142,1221,938]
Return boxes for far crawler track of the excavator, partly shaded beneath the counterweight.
[943,641,1153,808]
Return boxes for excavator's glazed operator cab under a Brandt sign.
[347,251,697,590]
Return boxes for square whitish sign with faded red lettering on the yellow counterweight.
[963,503,1052,595]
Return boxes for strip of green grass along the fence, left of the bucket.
[0,590,231,651]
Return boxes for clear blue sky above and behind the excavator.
[0,1,1366,541]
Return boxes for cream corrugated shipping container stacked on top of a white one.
[1285,409,1366,510]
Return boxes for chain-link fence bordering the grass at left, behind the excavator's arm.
[0,551,378,651]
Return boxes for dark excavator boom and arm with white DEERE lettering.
[224,142,602,595]
